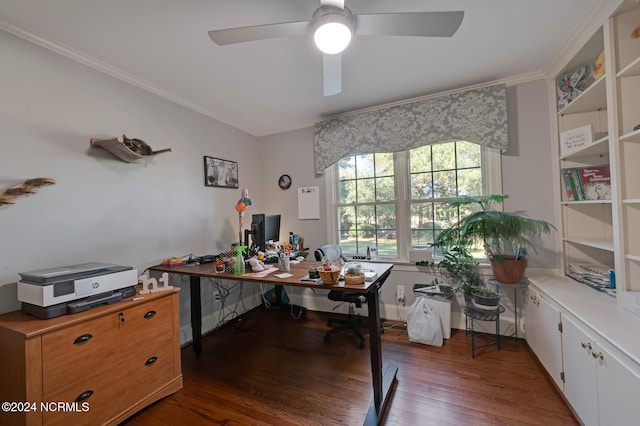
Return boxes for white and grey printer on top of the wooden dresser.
[18,262,138,319]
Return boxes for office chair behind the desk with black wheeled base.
[314,244,368,349]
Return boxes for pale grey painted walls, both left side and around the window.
[0,31,557,341]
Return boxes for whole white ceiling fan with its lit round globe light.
[209,0,464,96]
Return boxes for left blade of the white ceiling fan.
[209,21,309,46]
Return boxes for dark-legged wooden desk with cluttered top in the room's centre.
[149,262,398,425]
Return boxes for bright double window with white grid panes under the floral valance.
[327,141,501,261]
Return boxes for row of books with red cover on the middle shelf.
[561,165,611,201]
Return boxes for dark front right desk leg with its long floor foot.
[364,288,398,425]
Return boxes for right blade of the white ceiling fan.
[356,11,464,37]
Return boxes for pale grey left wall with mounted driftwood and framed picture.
[0,31,262,330]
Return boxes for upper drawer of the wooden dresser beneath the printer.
[42,298,173,399]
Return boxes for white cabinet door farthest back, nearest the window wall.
[524,286,563,390]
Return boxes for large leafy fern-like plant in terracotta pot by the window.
[434,195,555,284]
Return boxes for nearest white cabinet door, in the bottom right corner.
[594,345,640,425]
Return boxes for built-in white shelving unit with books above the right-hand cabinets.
[550,1,640,297]
